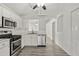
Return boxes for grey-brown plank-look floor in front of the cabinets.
[18,39,69,56]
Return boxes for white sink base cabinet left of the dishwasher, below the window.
[22,34,38,47]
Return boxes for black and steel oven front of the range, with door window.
[10,35,21,56]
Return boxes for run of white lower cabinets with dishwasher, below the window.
[22,34,46,47]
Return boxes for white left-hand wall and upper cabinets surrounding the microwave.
[0,4,22,35]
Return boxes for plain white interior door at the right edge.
[72,9,79,55]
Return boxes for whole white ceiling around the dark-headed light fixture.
[3,3,79,17]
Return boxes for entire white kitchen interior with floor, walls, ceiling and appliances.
[0,3,79,56]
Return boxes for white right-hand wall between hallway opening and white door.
[56,4,79,55]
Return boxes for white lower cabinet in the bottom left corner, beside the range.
[0,39,10,56]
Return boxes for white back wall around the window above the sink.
[22,15,48,33]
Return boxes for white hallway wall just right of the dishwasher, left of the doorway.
[46,18,56,46]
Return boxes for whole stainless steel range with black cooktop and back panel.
[0,31,21,56]
